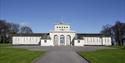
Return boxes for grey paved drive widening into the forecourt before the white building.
[14,46,113,63]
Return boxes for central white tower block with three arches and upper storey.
[50,22,75,46]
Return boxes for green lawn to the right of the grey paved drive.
[80,48,125,63]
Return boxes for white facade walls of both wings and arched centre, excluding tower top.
[12,33,111,46]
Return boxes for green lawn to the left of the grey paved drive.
[0,45,44,63]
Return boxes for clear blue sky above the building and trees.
[0,0,125,33]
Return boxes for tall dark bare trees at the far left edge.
[0,20,19,43]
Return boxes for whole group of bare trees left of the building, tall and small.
[0,20,32,43]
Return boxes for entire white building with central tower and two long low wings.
[12,23,111,46]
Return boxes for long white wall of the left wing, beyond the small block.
[12,36,41,45]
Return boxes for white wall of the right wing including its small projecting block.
[74,37,111,46]
